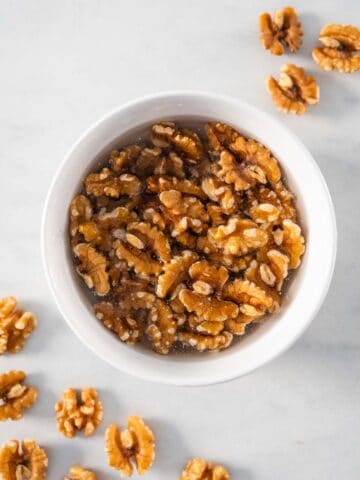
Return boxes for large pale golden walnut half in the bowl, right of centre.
[208,217,268,256]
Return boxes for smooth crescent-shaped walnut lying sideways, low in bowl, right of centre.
[179,289,238,322]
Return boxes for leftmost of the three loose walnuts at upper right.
[259,7,303,55]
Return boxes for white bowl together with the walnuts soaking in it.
[42,92,336,385]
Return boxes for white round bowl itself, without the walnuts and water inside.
[42,91,336,385]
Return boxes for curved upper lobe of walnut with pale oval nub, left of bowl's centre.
[127,222,171,262]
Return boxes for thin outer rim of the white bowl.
[41,90,337,386]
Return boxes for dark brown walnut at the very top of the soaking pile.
[151,122,203,160]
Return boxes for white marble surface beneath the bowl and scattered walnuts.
[0,0,360,480]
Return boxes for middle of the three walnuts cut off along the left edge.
[0,370,37,421]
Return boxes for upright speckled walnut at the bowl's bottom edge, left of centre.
[146,300,177,355]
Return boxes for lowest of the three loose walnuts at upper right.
[266,64,320,115]
